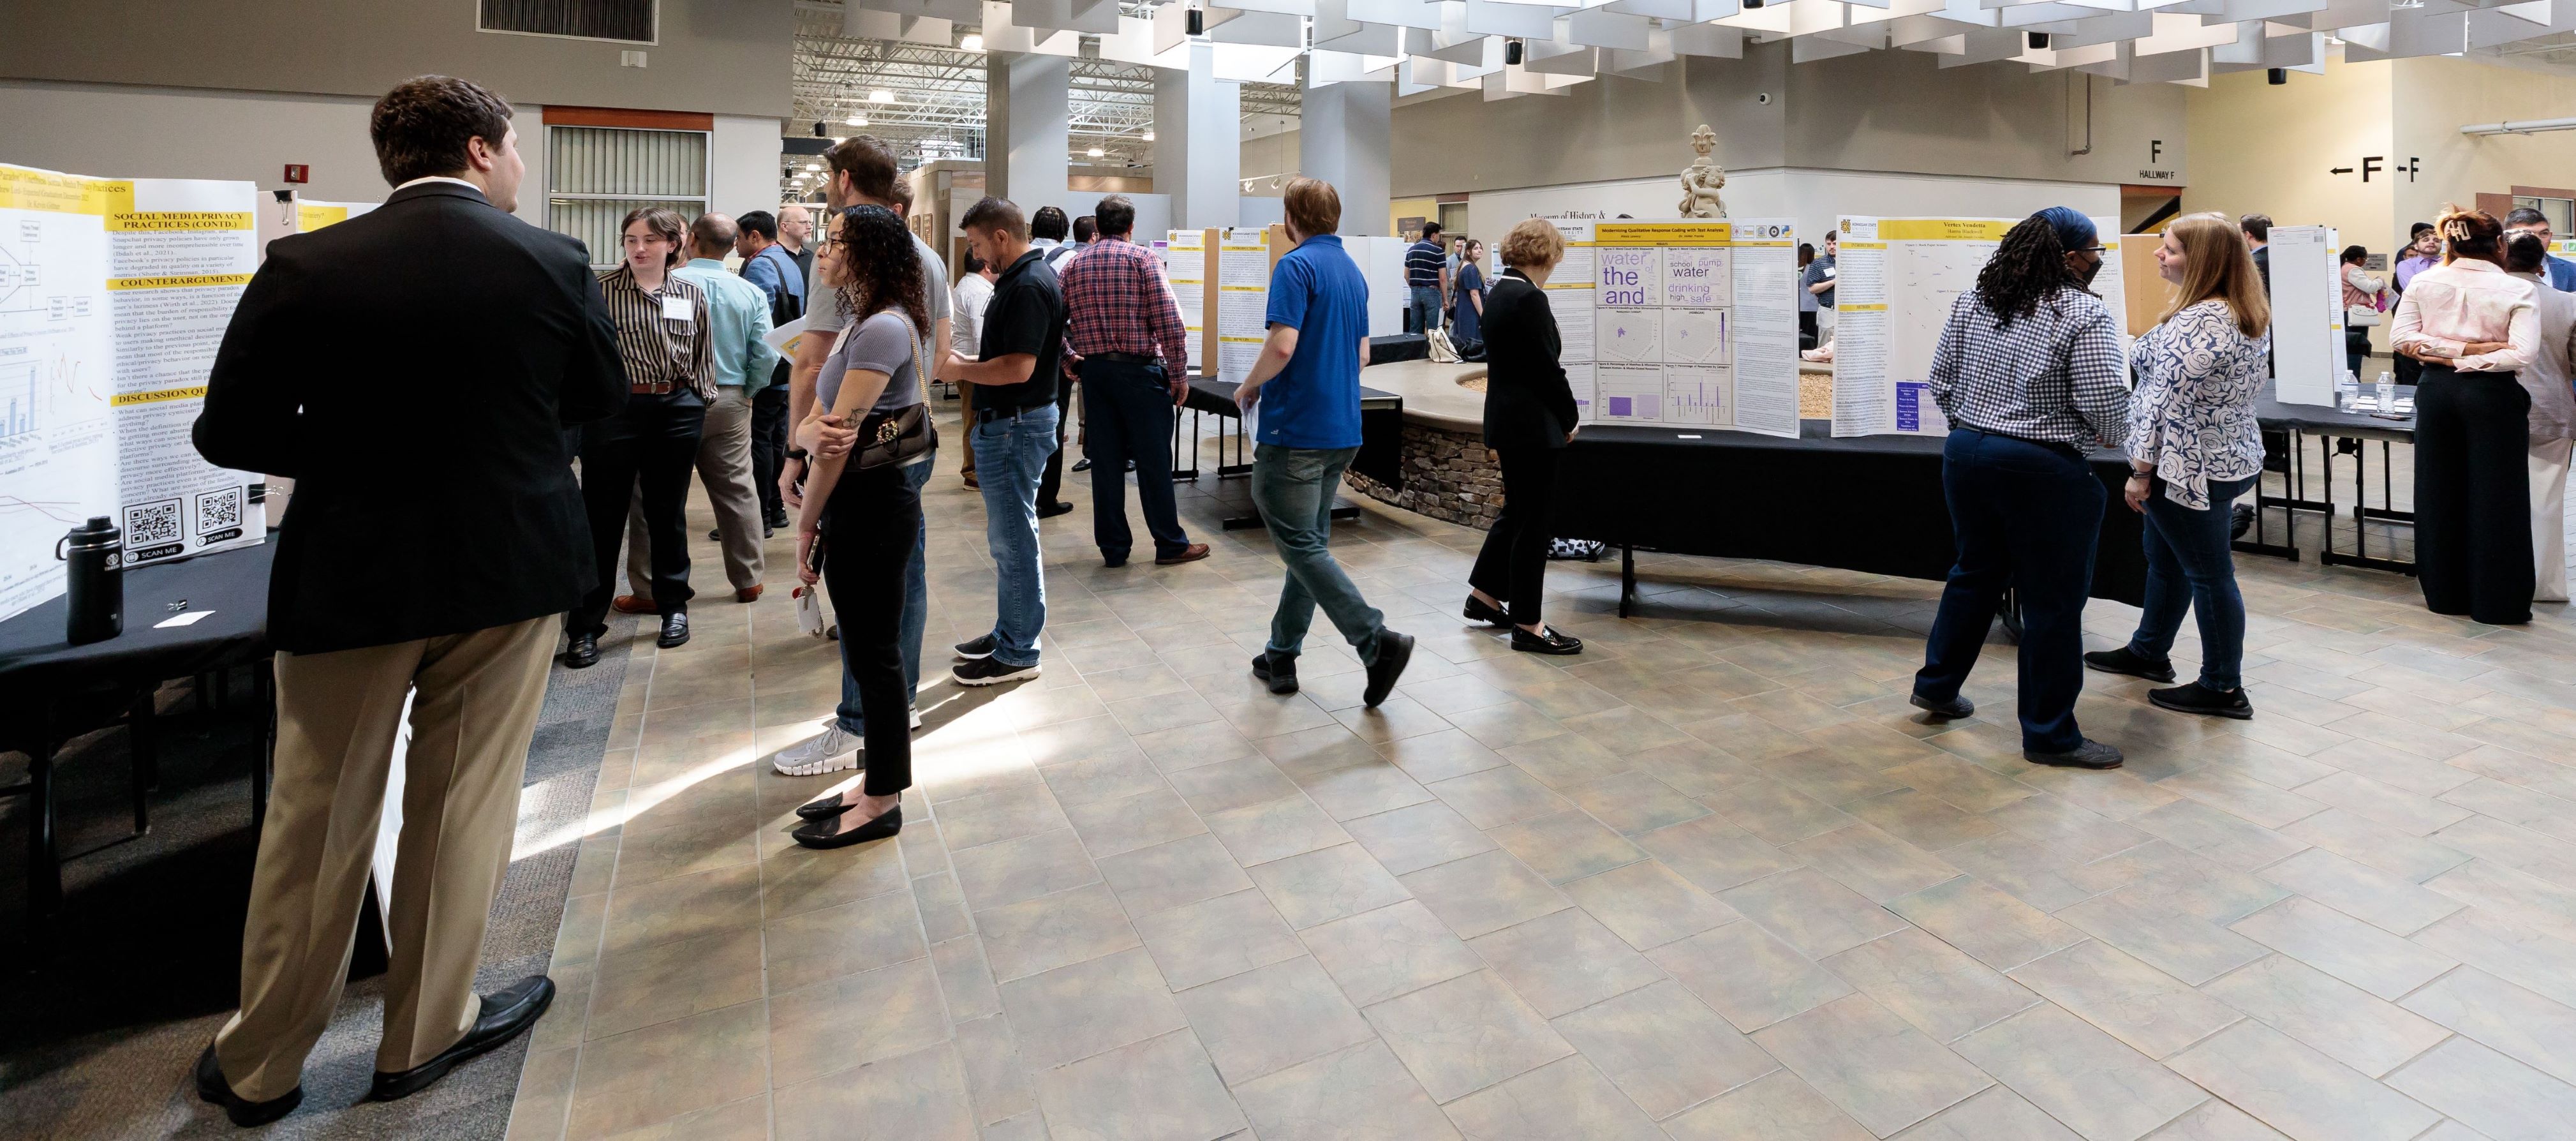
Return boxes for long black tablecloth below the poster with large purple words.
[1556,420,2146,605]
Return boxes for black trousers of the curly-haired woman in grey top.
[819,466,922,796]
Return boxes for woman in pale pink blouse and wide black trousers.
[2388,209,2540,626]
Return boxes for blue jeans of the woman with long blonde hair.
[2128,477,2261,693]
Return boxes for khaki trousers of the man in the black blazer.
[214,616,561,1102]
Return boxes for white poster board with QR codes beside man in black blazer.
[0,165,268,621]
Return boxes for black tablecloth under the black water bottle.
[0,541,276,721]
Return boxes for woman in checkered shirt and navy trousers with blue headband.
[1914,206,2128,768]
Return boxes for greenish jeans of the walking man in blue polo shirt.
[1252,443,1386,664]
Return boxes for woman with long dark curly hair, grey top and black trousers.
[778,206,930,847]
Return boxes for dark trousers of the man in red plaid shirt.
[1092,358,1190,559]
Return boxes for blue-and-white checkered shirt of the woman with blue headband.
[1932,288,2128,451]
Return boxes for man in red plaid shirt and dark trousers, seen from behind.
[1064,193,1208,567]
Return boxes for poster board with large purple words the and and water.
[1546,219,1798,438]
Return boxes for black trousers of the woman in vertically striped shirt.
[564,391,706,634]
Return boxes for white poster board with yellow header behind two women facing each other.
[1834,214,2130,435]
